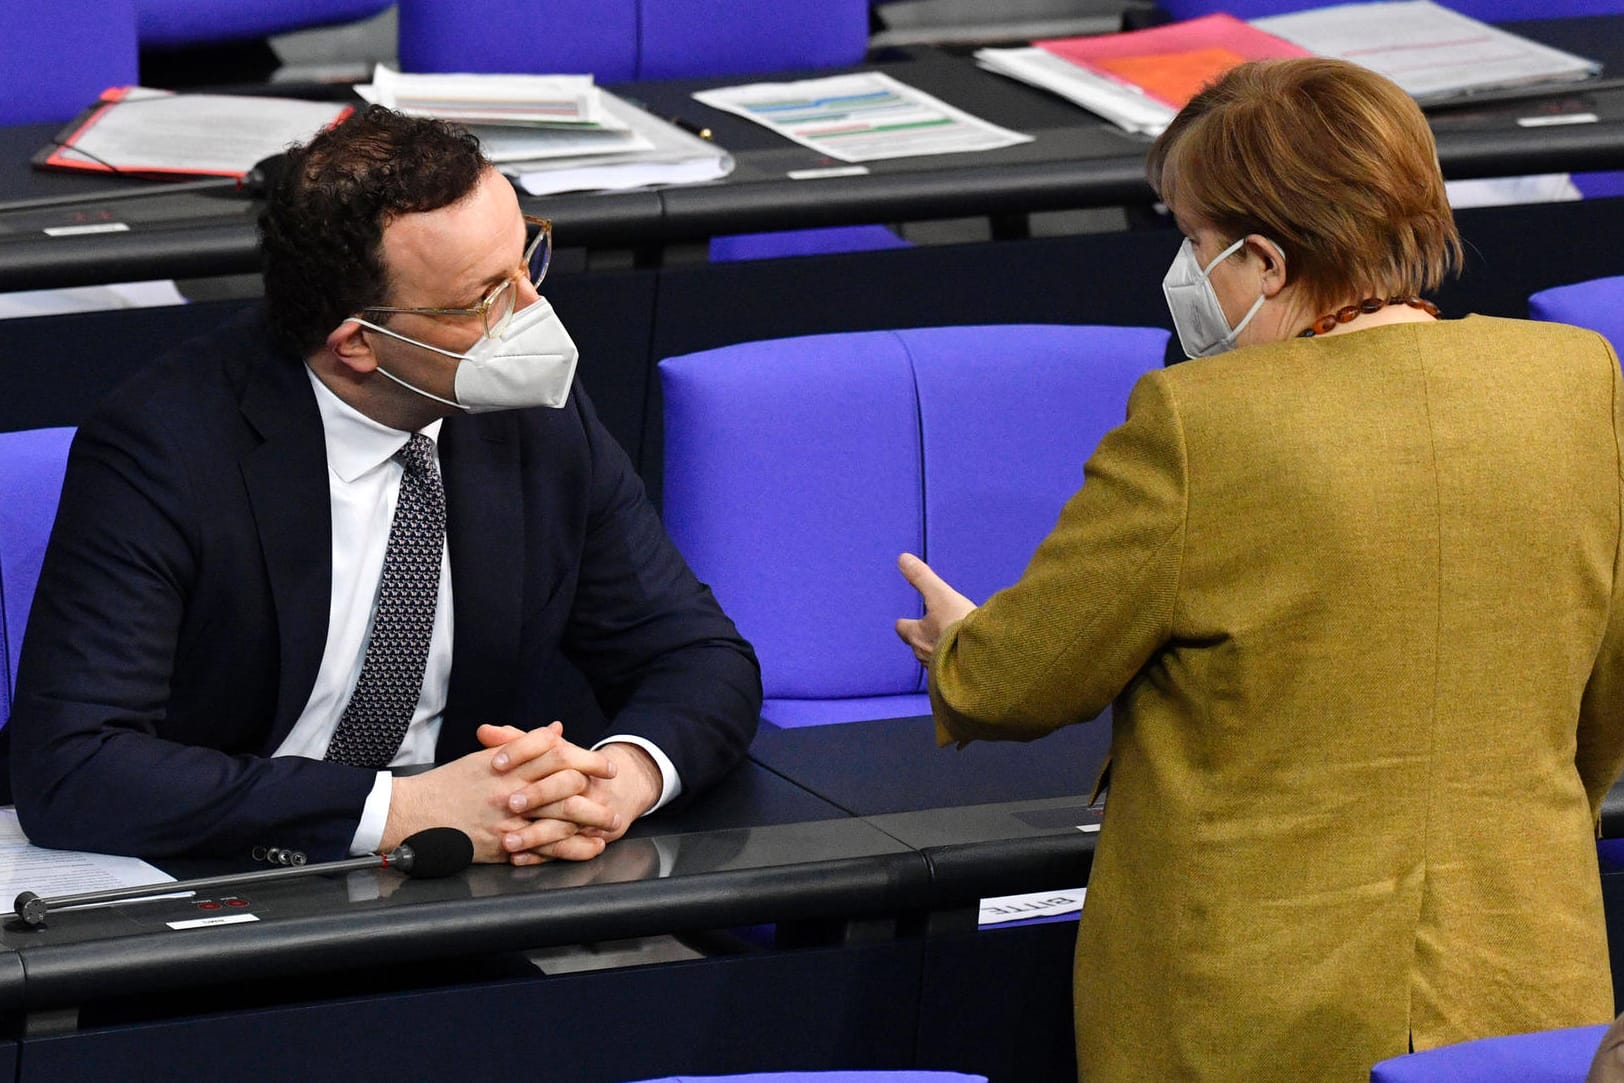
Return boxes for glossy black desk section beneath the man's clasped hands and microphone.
[0,763,927,1015]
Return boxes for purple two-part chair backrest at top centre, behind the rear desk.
[398,0,869,83]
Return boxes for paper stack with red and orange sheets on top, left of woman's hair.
[976,15,1309,135]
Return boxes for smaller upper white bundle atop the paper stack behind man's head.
[356,65,624,128]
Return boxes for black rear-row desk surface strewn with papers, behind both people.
[0,16,1624,289]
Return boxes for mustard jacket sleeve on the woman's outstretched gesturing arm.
[931,372,1189,744]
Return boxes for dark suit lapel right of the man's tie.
[438,412,526,746]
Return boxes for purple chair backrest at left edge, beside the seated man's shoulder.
[0,429,73,724]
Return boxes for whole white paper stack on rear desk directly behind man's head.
[356,67,732,195]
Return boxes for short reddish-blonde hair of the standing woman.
[1147,57,1462,312]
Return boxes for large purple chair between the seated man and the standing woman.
[659,325,1168,726]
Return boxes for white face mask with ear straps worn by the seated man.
[346,297,580,414]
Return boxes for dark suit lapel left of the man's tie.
[242,342,333,750]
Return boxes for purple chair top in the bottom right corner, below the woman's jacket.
[1371,1023,1608,1083]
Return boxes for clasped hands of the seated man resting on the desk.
[383,723,663,865]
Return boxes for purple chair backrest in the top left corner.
[0,0,136,123]
